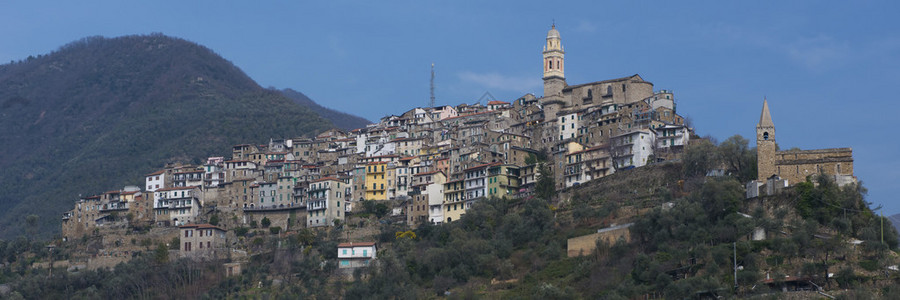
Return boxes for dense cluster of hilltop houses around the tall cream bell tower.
[62,26,696,241]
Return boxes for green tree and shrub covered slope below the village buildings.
[0,140,900,299]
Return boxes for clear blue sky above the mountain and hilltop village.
[0,1,900,214]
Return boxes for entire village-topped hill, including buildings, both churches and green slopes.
[0,22,884,299]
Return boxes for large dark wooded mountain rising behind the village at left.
[0,34,331,237]
